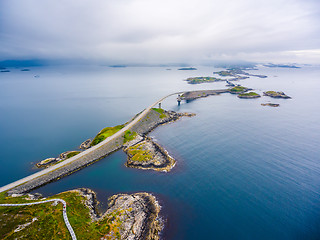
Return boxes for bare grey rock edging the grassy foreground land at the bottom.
[74,188,163,240]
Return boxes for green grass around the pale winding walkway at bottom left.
[0,192,131,240]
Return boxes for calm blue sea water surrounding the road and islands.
[0,66,320,239]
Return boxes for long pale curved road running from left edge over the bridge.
[0,91,185,192]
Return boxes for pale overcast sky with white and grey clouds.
[0,0,320,64]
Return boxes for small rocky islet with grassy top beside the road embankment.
[123,137,176,172]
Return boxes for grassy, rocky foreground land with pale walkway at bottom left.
[0,188,163,240]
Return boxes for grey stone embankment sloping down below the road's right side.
[8,109,192,194]
